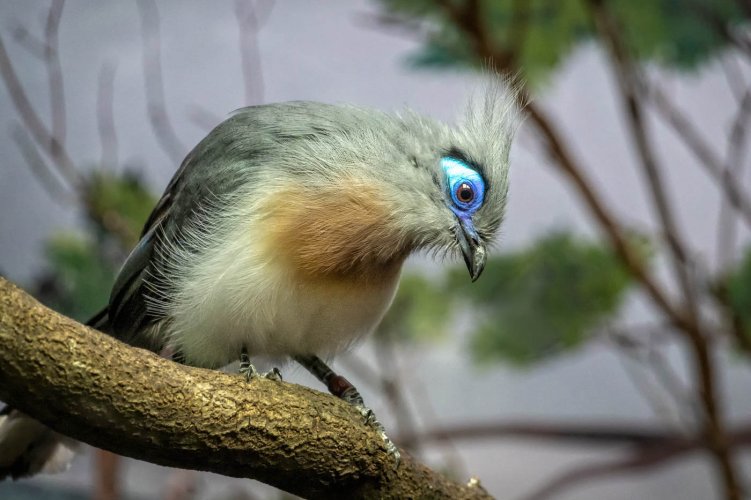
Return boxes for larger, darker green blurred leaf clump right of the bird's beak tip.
[451,233,630,365]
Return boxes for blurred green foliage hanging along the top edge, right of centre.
[380,0,745,85]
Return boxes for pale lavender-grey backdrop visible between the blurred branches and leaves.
[0,0,751,500]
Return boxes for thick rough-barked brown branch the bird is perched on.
[0,277,490,499]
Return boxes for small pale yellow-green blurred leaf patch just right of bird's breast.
[377,274,452,340]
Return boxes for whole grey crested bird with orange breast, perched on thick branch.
[0,84,519,479]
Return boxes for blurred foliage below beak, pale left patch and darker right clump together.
[379,233,636,366]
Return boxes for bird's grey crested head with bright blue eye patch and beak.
[362,85,518,281]
